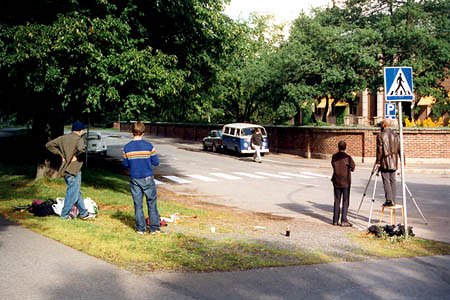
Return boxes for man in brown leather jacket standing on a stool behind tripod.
[376,119,400,206]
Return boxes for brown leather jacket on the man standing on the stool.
[376,128,400,171]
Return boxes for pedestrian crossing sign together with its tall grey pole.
[384,67,414,238]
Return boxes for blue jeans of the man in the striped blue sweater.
[130,176,160,232]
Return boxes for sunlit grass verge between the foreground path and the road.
[0,163,450,273]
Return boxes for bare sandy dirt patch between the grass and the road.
[159,187,362,260]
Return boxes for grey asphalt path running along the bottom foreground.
[0,218,450,300]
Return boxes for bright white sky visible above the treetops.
[225,0,331,23]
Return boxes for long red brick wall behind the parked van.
[120,122,450,162]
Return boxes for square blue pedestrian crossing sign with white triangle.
[384,67,414,102]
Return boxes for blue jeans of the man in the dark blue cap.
[61,172,88,219]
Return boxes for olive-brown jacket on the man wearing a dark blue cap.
[45,132,86,176]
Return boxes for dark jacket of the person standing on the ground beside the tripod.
[331,151,355,188]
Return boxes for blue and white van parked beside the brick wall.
[222,123,269,154]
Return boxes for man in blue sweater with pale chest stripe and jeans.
[122,122,160,234]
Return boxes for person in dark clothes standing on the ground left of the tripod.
[331,141,355,227]
